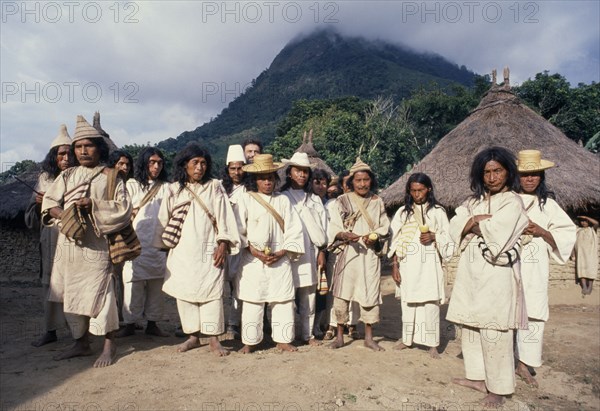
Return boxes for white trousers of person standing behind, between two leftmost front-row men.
[123,278,165,324]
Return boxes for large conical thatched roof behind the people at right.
[381,85,600,212]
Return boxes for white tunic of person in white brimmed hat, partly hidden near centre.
[281,188,327,288]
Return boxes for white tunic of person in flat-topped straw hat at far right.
[521,194,576,321]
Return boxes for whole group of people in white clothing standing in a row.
[26,116,598,405]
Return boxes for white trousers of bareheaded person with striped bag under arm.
[177,298,225,335]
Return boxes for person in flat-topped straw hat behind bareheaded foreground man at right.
[515,150,575,387]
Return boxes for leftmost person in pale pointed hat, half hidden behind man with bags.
[25,124,73,347]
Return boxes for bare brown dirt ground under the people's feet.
[0,275,600,411]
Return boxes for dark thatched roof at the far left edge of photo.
[0,166,40,225]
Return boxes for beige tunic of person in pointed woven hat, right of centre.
[327,193,390,307]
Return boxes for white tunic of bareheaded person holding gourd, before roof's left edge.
[389,206,453,303]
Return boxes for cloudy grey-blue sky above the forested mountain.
[0,0,600,171]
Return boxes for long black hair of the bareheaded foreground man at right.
[470,147,519,199]
